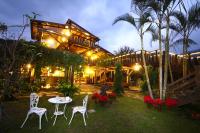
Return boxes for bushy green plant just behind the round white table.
[58,81,79,97]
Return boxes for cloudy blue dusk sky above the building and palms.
[0,0,200,52]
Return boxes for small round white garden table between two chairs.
[48,97,72,126]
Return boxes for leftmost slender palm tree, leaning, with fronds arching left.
[113,2,153,98]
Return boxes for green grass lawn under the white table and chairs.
[0,96,200,133]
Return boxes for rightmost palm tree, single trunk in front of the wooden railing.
[170,2,200,76]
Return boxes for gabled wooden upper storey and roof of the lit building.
[31,19,113,56]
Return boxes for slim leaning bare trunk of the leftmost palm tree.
[140,29,153,98]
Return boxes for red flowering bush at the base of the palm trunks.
[144,96,177,110]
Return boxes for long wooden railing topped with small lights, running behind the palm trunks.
[101,50,200,80]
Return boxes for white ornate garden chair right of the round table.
[69,95,88,126]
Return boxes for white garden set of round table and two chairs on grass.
[21,93,88,129]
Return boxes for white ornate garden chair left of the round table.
[21,93,48,129]
